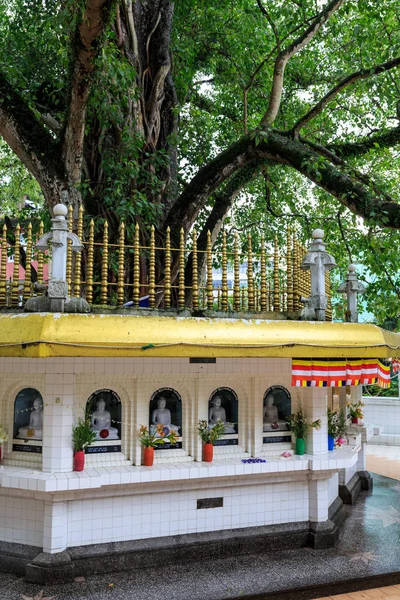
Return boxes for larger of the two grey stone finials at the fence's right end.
[300,229,336,321]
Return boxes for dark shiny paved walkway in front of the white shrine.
[0,446,400,600]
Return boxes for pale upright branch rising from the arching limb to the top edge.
[261,0,345,126]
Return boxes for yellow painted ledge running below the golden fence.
[0,313,400,358]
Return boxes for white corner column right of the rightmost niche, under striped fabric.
[300,387,328,454]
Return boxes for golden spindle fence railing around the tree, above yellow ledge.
[0,210,332,320]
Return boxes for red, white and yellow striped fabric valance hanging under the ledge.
[292,359,390,388]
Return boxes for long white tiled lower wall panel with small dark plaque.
[68,479,308,546]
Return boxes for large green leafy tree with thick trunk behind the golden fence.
[0,0,400,310]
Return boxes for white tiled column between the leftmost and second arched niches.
[42,370,75,473]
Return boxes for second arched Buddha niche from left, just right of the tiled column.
[86,389,122,454]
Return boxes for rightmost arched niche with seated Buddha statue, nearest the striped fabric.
[263,385,292,444]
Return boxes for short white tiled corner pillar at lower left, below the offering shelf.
[43,502,68,554]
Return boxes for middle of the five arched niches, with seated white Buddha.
[149,388,182,450]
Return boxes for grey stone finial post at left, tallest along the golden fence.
[25,204,90,312]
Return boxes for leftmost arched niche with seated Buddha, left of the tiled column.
[13,388,43,453]
